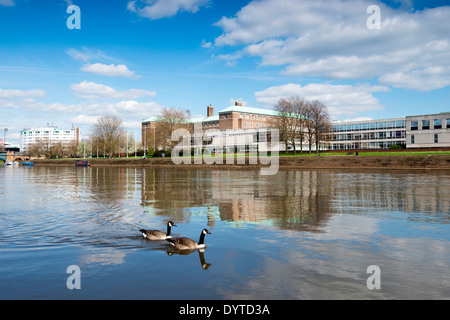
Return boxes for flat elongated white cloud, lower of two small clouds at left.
[70,81,156,99]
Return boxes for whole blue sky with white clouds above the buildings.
[0,0,450,144]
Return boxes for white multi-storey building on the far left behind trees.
[20,127,80,153]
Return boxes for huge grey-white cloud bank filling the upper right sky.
[214,0,450,91]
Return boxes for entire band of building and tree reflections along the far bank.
[26,167,450,232]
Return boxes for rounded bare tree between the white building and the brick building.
[91,115,126,158]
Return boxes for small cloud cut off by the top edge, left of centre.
[127,0,209,20]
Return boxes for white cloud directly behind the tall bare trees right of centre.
[255,83,389,119]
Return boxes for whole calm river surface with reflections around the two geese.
[0,167,450,299]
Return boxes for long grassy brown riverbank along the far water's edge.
[33,155,450,170]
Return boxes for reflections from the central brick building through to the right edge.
[141,169,450,232]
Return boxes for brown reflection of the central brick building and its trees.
[141,169,332,231]
